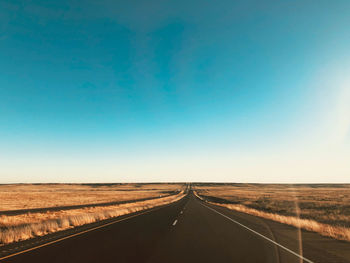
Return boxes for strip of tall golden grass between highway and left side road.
[0,192,184,244]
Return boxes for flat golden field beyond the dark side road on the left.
[0,184,183,212]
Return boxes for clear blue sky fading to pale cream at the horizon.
[0,0,350,183]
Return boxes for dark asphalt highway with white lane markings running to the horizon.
[1,193,350,263]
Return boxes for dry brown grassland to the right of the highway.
[194,184,350,241]
